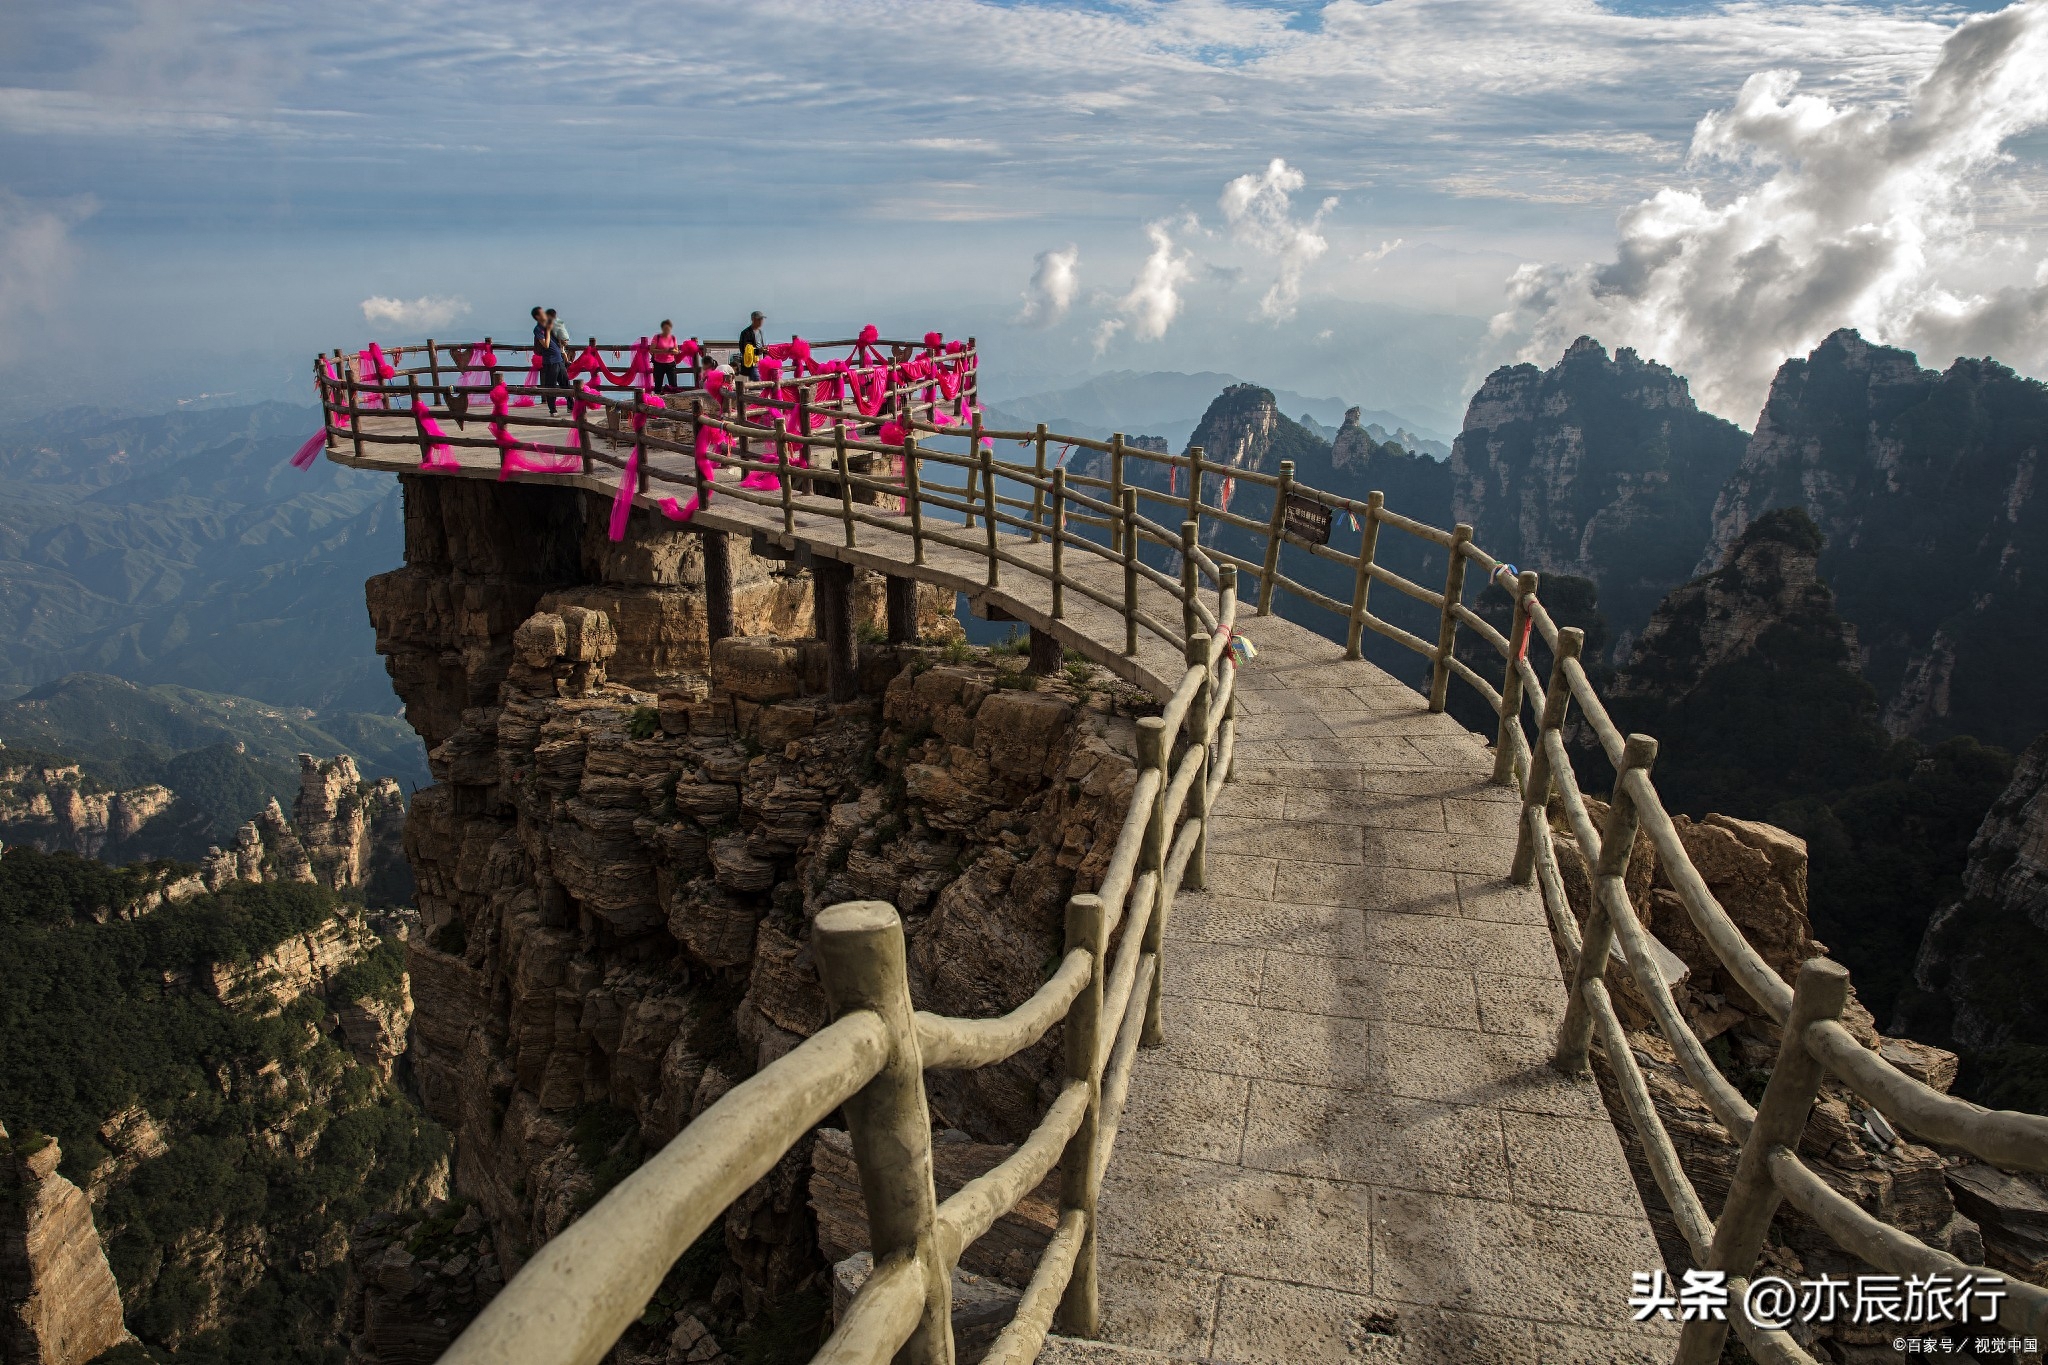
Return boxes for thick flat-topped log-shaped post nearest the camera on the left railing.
[811,900,952,1365]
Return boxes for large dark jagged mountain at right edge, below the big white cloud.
[1700,329,2048,749]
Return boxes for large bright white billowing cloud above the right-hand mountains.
[1493,0,2048,422]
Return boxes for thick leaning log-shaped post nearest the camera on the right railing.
[1675,958,1849,1365]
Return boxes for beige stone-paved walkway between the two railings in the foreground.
[1040,618,1675,1365]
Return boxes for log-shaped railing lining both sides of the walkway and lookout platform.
[315,336,2048,1365]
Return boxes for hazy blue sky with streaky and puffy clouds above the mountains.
[0,0,2048,430]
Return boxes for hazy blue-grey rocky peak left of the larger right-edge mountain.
[1449,336,1743,651]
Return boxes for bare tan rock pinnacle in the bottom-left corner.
[0,1128,129,1365]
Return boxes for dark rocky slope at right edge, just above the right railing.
[1898,735,2048,1050]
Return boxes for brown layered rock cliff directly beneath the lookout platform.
[365,481,1133,1359]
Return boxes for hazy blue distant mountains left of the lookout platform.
[0,403,401,712]
